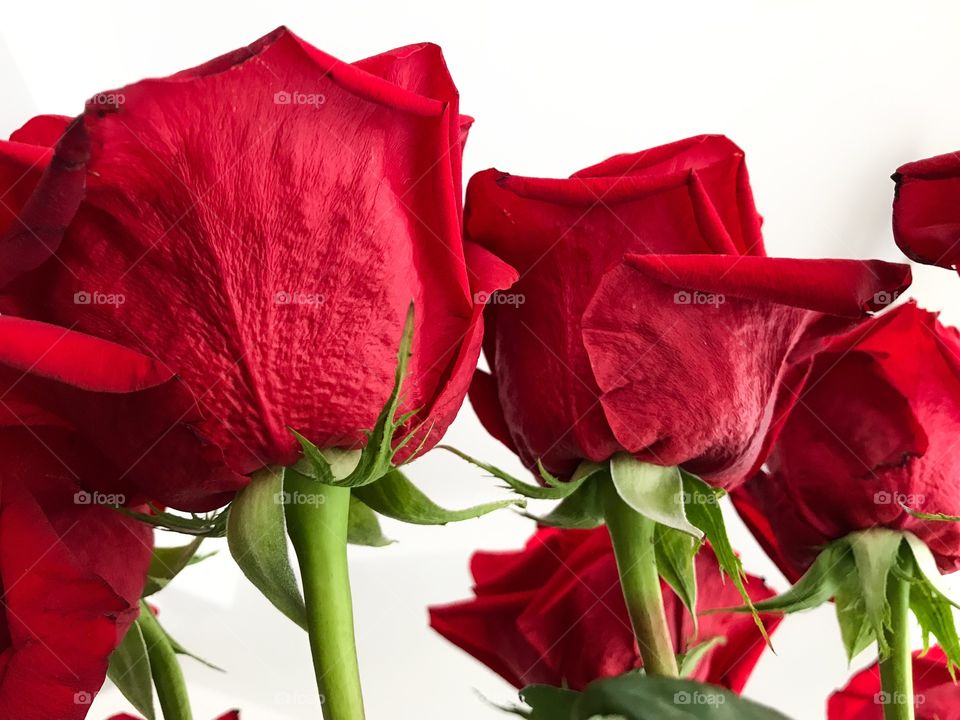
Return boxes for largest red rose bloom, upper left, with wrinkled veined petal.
[0,28,514,509]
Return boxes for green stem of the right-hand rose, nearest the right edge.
[880,563,914,720]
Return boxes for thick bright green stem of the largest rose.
[284,472,364,720]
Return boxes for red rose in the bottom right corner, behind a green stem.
[827,647,960,720]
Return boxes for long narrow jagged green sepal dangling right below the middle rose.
[680,470,770,645]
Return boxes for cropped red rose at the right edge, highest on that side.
[893,153,960,268]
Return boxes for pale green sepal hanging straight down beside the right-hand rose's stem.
[846,528,903,657]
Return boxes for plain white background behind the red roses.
[0,0,960,720]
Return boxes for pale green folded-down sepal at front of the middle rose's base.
[610,453,703,540]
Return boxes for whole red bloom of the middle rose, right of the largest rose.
[465,136,909,487]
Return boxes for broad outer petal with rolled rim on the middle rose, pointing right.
[583,255,909,488]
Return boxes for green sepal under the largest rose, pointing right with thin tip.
[353,470,525,525]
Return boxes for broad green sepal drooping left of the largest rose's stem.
[227,468,307,630]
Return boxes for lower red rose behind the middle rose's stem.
[430,527,780,692]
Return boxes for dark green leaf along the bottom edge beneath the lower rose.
[510,673,787,720]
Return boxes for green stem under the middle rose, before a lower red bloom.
[603,482,680,677]
